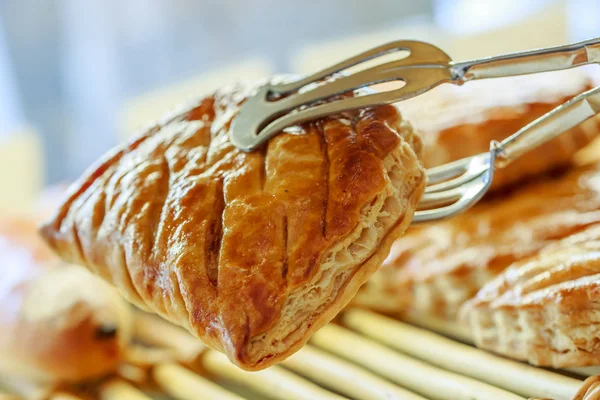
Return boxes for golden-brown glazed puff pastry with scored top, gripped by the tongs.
[43,79,425,370]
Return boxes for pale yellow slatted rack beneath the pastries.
[0,309,600,400]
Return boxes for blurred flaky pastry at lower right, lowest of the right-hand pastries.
[461,224,600,368]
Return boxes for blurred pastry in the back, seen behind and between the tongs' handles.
[399,70,600,190]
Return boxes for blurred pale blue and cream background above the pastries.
[0,0,600,212]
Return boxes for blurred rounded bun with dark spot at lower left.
[0,218,131,382]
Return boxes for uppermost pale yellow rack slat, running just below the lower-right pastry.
[342,310,581,400]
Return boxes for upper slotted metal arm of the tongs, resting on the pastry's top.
[231,38,600,151]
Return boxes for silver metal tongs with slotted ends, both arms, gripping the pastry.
[231,38,600,222]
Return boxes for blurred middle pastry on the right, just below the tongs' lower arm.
[355,159,600,319]
